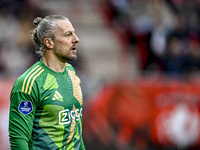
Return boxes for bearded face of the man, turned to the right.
[54,20,79,62]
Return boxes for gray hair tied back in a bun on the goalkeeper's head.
[30,15,69,56]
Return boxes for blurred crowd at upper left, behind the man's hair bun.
[0,0,50,77]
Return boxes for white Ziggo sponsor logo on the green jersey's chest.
[59,108,82,125]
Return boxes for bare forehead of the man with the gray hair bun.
[56,20,74,32]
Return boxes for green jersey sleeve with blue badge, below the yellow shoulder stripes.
[9,92,36,150]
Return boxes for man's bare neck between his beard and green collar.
[42,53,66,72]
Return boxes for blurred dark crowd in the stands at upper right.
[102,0,200,75]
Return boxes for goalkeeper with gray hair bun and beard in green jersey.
[9,15,85,150]
